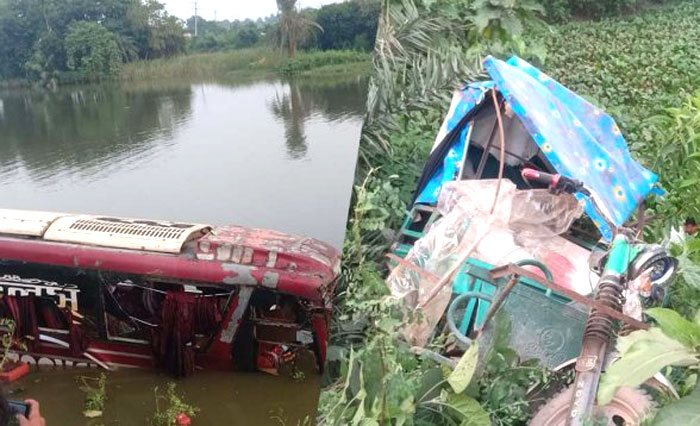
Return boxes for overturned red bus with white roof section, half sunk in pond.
[0,210,340,377]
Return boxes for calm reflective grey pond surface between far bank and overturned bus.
[0,72,367,247]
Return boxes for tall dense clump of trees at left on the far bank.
[0,0,185,83]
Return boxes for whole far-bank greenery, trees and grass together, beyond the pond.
[0,0,379,87]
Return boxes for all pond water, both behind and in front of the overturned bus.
[0,72,367,426]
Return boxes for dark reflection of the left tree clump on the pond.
[0,85,192,181]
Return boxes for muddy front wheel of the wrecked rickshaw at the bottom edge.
[529,386,657,426]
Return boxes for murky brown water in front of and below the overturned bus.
[10,368,320,426]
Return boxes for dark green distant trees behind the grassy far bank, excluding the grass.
[0,0,380,84]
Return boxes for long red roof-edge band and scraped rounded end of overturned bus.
[0,227,340,300]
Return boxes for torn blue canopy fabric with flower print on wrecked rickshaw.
[416,57,663,240]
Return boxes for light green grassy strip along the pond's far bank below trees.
[119,48,370,80]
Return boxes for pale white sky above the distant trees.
[160,0,339,21]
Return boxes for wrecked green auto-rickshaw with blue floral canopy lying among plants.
[387,57,677,426]
